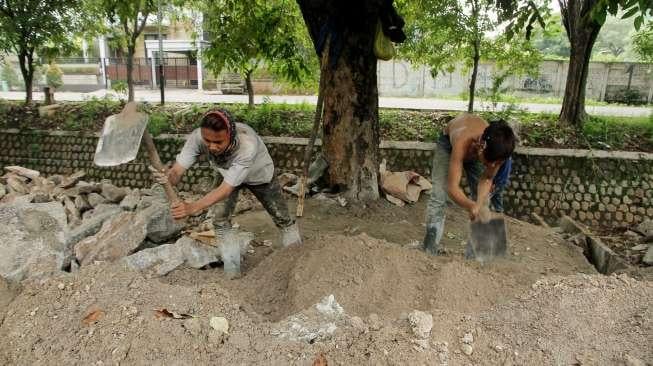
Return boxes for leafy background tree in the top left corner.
[0,0,87,103]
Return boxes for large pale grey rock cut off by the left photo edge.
[0,201,66,281]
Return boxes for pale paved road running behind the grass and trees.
[0,89,652,117]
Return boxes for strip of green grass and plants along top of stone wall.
[0,99,653,152]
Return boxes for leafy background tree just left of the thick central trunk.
[196,0,316,107]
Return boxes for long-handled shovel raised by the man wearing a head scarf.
[93,102,179,202]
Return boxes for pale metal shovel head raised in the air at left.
[93,102,148,166]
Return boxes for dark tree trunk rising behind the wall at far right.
[559,0,601,127]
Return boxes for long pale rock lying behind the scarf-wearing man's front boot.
[123,232,254,276]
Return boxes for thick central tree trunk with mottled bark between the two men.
[298,0,381,201]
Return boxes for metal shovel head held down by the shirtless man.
[470,217,508,262]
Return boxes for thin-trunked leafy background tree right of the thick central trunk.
[397,0,541,112]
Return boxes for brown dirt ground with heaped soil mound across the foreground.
[0,199,653,365]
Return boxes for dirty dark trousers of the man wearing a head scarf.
[211,172,295,232]
